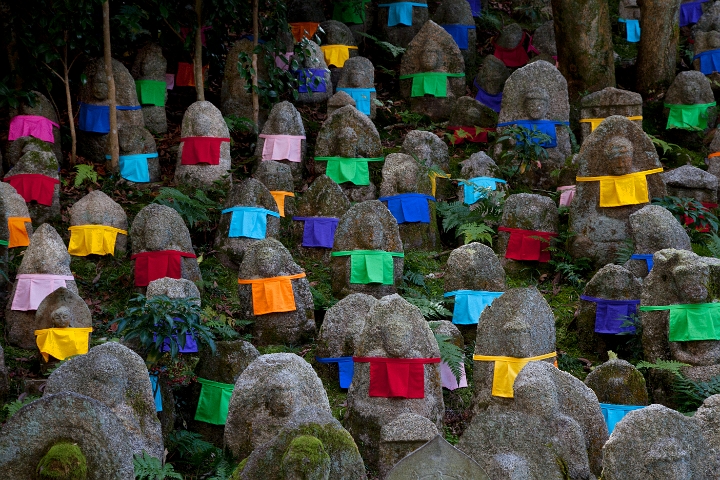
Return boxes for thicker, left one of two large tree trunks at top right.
[552,0,615,101]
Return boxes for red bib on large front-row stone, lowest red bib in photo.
[353,357,440,398]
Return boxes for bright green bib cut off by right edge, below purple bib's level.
[640,303,720,342]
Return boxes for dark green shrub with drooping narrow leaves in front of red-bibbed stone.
[113,295,215,365]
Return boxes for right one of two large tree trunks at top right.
[635,0,680,98]
